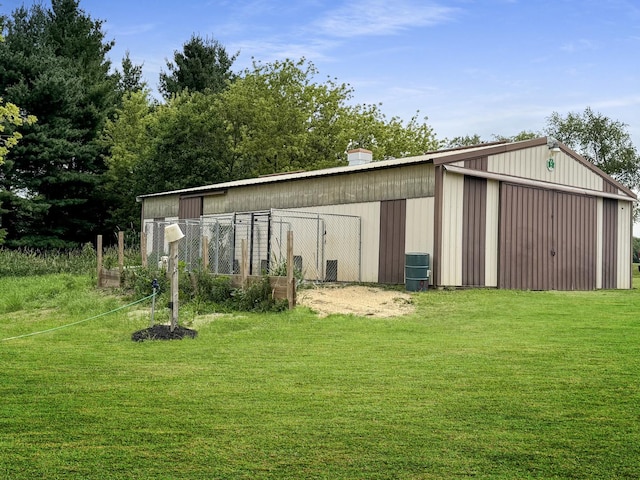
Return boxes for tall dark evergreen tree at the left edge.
[0,0,118,248]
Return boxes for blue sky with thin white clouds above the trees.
[0,0,640,148]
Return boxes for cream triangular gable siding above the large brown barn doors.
[488,146,604,191]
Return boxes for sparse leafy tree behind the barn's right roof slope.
[545,107,640,189]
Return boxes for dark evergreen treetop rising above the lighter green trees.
[159,35,238,99]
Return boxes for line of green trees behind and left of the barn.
[0,0,640,249]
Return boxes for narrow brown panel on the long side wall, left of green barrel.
[378,200,407,284]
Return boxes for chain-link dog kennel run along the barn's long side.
[144,209,361,282]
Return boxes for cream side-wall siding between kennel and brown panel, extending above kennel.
[294,202,380,283]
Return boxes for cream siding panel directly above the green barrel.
[404,197,435,283]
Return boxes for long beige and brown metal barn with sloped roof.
[138,137,636,290]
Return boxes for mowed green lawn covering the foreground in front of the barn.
[0,276,640,479]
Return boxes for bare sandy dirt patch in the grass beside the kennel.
[298,286,414,317]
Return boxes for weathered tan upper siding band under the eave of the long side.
[204,164,435,215]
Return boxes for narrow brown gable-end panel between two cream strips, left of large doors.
[462,177,487,286]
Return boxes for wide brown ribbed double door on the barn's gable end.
[499,183,597,290]
